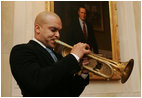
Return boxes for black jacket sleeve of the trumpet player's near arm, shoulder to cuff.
[10,45,80,93]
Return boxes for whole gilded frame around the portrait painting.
[45,1,120,80]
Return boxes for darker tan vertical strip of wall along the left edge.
[1,2,14,96]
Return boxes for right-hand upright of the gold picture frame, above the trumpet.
[109,1,120,62]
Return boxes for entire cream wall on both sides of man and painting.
[2,1,141,97]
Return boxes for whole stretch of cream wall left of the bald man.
[1,1,45,97]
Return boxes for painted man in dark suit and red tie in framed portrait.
[65,6,98,53]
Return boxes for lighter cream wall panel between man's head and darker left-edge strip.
[13,1,45,45]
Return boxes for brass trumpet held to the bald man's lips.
[55,40,134,83]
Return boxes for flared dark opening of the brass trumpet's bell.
[121,59,134,83]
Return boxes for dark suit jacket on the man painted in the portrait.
[65,18,98,53]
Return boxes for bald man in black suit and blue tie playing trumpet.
[10,12,90,97]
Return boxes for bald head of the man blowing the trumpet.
[34,12,62,48]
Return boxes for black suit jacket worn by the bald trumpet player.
[10,40,89,97]
